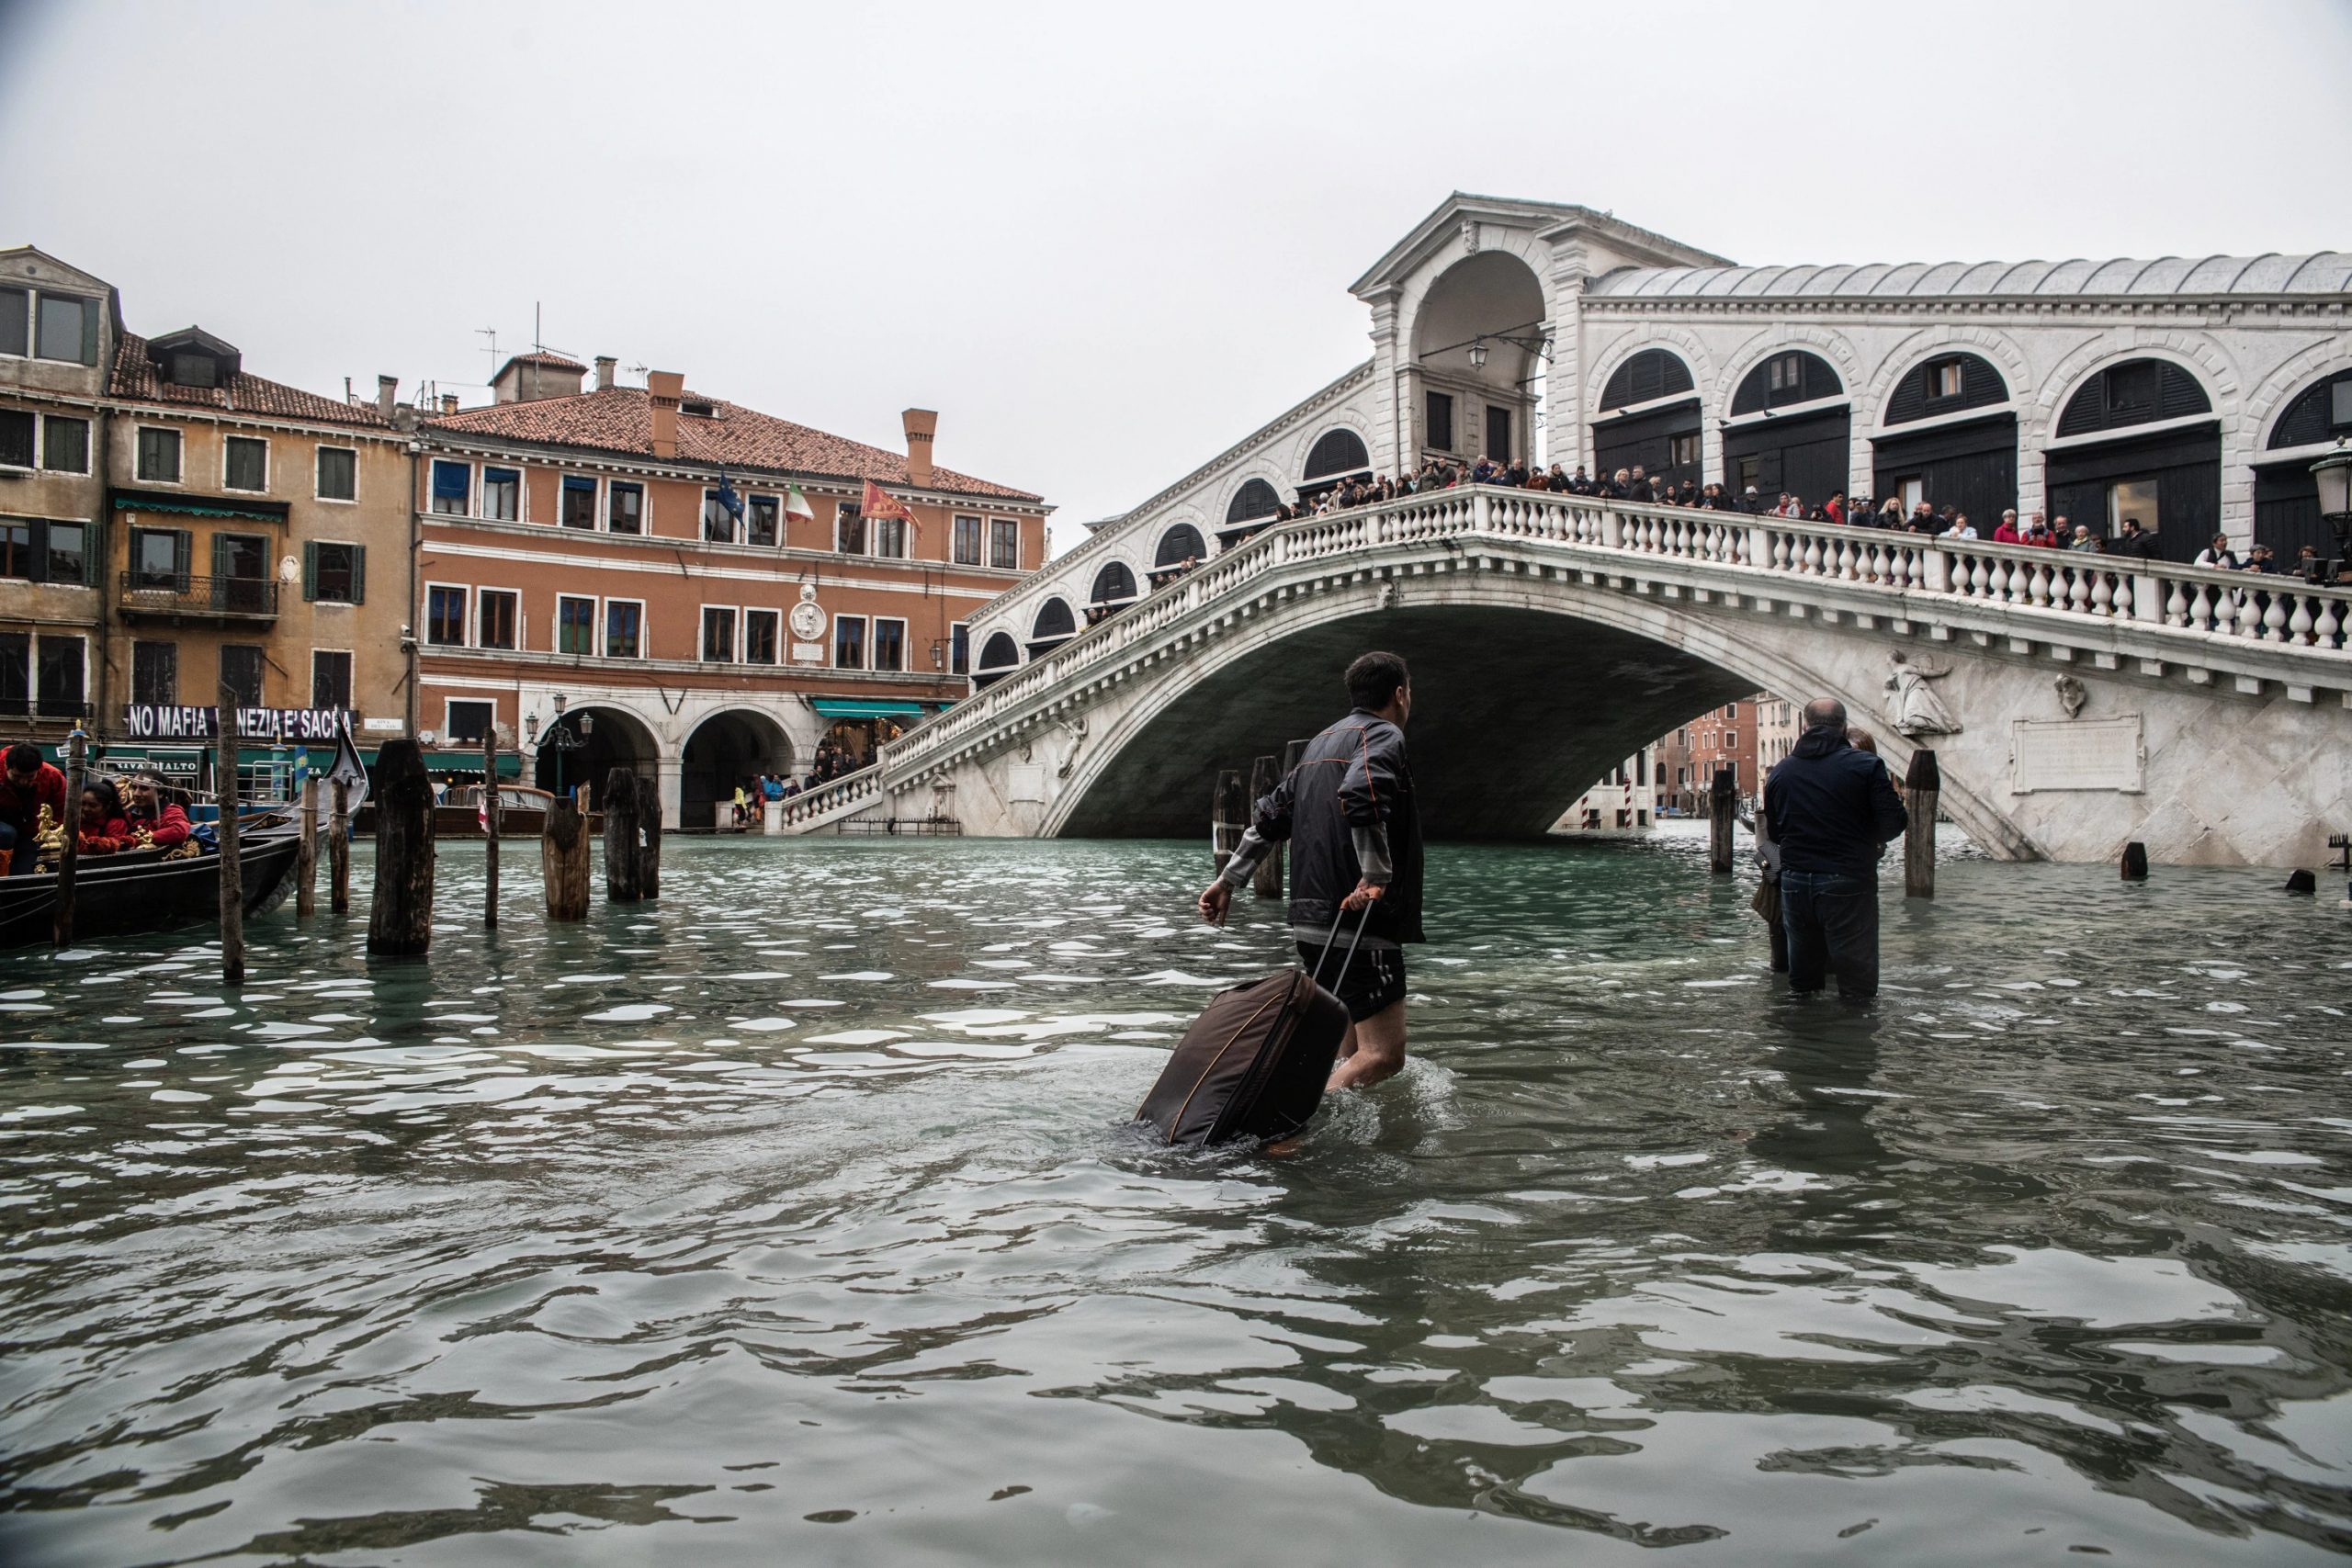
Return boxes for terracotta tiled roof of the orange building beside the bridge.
[421,386,1040,501]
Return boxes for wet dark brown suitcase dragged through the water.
[1136,909,1371,1147]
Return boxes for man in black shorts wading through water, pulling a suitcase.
[1200,653,1423,1089]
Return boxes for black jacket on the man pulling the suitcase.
[1251,707,1425,942]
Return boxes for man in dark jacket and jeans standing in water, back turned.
[1764,698,1910,999]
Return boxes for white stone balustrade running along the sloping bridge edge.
[786,487,2352,823]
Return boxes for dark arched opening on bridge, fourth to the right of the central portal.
[2051,357,2221,562]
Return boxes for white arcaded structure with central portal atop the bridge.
[976,195,2352,680]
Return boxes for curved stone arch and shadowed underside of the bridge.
[1042,573,2041,858]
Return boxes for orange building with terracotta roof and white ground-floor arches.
[412,353,1051,829]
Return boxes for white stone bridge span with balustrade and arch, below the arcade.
[786,487,2352,865]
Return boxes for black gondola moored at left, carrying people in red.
[0,818,301,947]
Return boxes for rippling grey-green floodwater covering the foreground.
[0,837,2352,1568]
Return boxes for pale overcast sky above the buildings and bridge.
[0,0,2352,546]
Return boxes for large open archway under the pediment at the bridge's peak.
[1399,252,1550,466]
